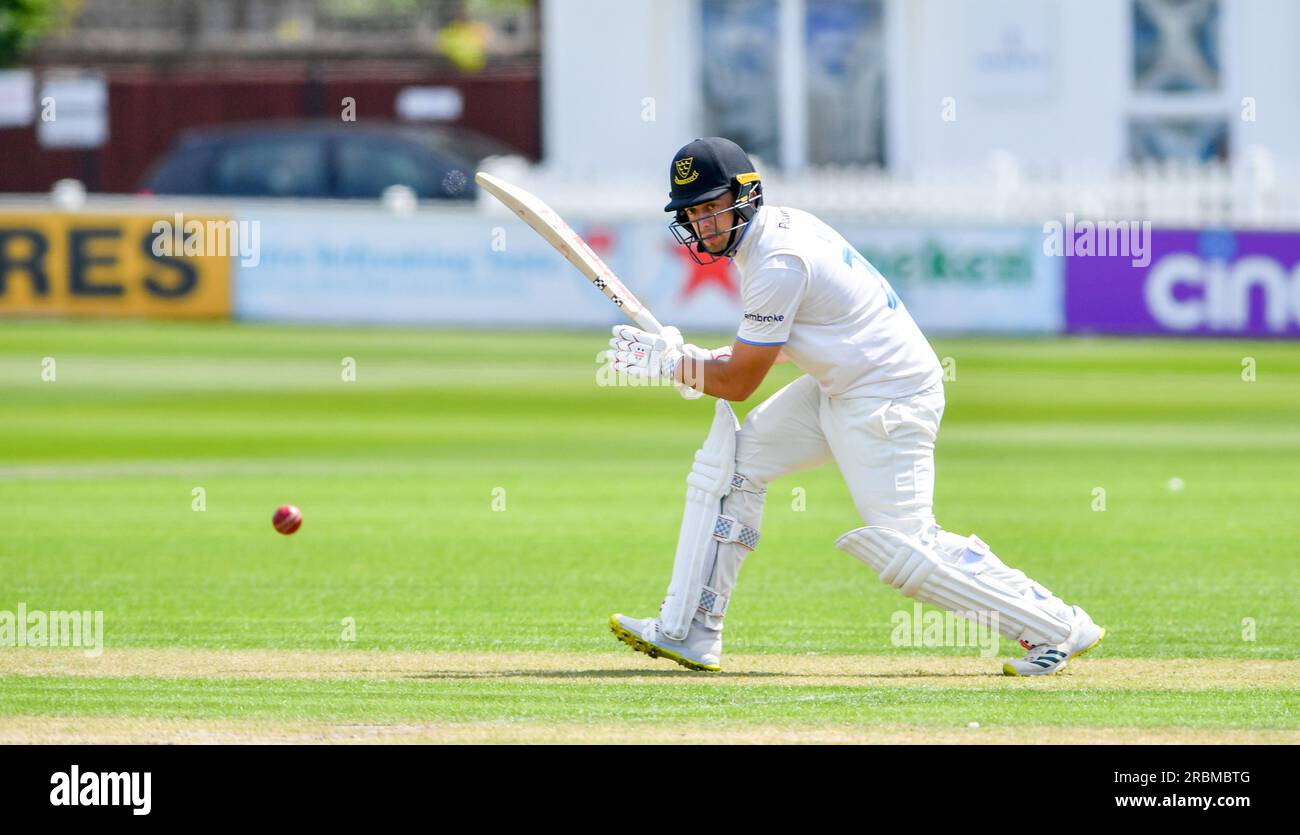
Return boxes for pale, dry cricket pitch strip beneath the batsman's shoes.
[0,648,1300,744]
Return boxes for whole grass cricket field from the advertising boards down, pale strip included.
[0,320,1300,741]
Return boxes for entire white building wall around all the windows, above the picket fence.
[542,0,1300,175]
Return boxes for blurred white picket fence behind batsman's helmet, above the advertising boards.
[482,150,1300,229]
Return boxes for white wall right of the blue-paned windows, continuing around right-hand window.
[888,0,1300,172]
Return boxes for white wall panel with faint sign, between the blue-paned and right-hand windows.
[889,0,1130,170]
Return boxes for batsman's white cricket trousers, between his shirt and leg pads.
[736,375,946,545]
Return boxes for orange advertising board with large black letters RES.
[0,213,231,319]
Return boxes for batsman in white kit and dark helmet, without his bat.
[610,137,1106,675]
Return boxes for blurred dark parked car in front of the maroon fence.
[133,121,520,200]
